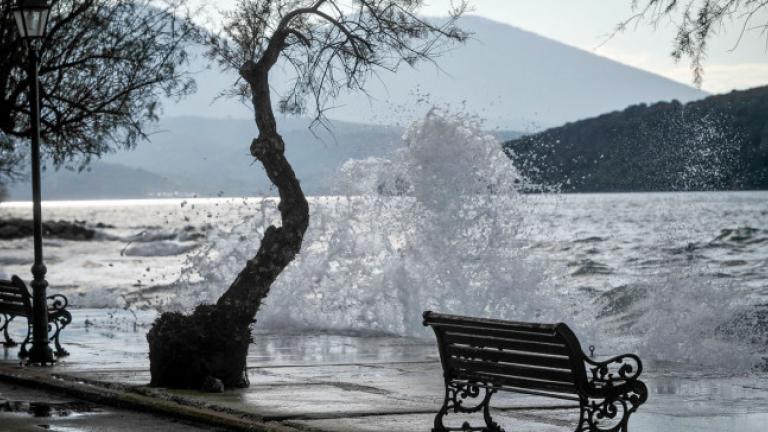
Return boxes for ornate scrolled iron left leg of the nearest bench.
[432,382,504,432]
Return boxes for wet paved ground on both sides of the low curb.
[0,309,768,432]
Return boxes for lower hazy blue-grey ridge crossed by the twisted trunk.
[111,117,408,196]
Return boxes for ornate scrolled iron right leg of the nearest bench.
[576,381,648,432]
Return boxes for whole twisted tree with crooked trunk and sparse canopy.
[147,0,466,388]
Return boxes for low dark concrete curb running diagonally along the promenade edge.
[0,365,306,432]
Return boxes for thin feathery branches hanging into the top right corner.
[616,0,768,85]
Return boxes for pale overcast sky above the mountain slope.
[192,0,768,93]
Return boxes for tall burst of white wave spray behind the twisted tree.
[165,110,557,335]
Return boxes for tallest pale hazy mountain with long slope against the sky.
[166,16,707,131]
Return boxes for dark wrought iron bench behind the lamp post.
[0,276,72,358]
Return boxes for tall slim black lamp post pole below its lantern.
[29,42,54,365]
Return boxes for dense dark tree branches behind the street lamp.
[0,0,200,183]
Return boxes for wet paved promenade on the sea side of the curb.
[0,309,768,432]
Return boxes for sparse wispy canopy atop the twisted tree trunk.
[209,0,467,127]
